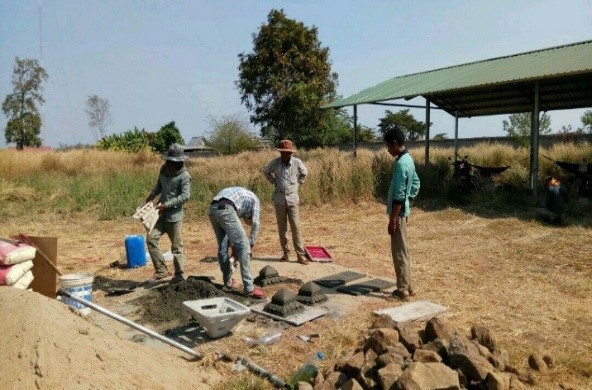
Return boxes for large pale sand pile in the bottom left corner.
[0,288,220,389]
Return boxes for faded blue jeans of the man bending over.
[208,204,254,293]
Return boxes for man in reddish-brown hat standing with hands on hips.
[263,139,308,264]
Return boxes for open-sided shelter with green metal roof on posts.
[322,40,592,196]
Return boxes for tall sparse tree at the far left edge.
[2,57,48,150]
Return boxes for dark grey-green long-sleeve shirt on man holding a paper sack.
[150,164,191,222]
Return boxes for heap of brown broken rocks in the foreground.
[308,315,553,390]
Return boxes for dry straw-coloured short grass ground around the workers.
[0,202,592,389]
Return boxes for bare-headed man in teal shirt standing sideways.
[384,125,419,299]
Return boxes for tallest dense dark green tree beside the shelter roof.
[236,9,337,147]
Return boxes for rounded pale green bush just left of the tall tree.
[208,115,259,155]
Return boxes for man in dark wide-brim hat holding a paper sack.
[146,144,191,283]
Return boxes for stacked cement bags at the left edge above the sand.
[0,238,35,290]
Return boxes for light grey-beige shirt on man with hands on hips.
[263,156,308,206]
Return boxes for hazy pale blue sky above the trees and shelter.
[0,0,592,147]
